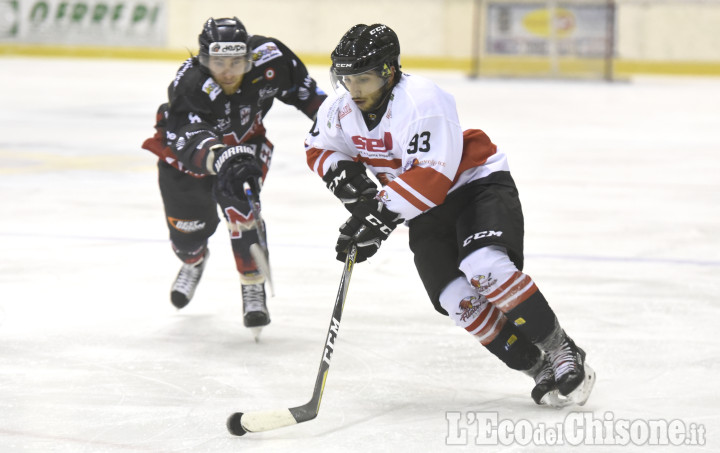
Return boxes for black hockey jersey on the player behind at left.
[143,35,326,174]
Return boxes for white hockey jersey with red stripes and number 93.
[305,74,509,220]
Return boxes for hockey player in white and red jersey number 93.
[305,24,595,406]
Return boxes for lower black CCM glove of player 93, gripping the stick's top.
[335,199,403,263]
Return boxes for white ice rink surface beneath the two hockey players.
[0,57,720,453]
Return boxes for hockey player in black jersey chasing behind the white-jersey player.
[143,18,326,328]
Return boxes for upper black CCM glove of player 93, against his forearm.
[323,160,377,212]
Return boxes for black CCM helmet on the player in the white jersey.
[330,24,400,77]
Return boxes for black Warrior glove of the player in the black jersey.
[213,145,262,200]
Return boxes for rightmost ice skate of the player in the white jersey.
[548,333,595,406]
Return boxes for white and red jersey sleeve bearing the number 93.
[380,107,463,220]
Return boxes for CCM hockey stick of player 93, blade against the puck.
[227,244,357,436]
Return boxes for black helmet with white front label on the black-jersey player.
[198,17,250,69]
